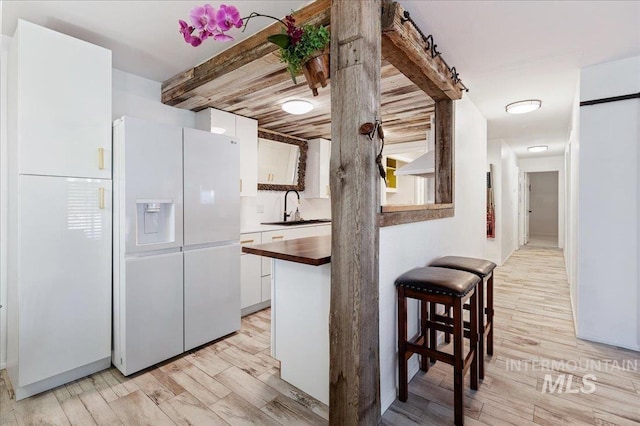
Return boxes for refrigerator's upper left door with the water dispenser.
[122,117,183,253]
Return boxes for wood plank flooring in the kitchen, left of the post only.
[0,309,329,426]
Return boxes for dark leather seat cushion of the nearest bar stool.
[396,266,480,297]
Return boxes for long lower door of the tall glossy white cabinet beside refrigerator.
[16,176,112,386]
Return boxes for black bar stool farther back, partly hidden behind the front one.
[431,256,496,379]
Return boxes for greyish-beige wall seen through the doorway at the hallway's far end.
[529,172,559,238]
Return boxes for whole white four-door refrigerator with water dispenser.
[112,117,240,375]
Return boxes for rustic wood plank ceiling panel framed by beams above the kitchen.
[176,54,434,143]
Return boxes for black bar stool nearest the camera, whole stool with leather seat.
[395,266,481,425]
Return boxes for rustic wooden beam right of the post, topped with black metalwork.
[382,0,463,101]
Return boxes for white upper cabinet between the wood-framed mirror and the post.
[304,139,331,198]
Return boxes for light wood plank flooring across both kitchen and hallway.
[0,247,640,426]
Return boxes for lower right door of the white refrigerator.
[184,244,240,351]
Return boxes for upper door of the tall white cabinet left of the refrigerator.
[9,20,111,179]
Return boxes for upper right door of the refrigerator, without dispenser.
[184,128,240,246]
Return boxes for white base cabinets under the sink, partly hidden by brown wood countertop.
[240,223,331,316]
